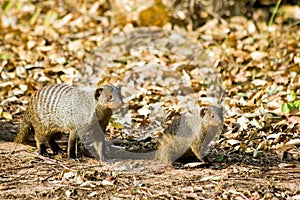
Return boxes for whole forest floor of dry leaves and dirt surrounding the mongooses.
[0,0,300,199]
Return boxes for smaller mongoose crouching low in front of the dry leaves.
[156,106,223,163]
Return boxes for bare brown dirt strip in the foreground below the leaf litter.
[0,124,300,199]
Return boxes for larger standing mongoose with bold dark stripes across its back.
[16,84,123,160]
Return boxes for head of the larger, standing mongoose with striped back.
[95,85,123,109]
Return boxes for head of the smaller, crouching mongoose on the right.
[200,106,224,126]
